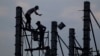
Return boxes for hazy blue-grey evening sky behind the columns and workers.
[0,0,100,56]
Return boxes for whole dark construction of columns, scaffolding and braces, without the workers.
[15,1,100,56]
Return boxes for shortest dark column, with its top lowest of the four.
[69,28,75,56]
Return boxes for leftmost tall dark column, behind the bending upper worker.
[15,6,22,56]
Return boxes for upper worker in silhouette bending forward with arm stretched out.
[25,6,42,29]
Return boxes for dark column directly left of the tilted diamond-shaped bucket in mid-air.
[51,21,57,56]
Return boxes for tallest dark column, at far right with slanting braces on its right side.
[82,1,90,56]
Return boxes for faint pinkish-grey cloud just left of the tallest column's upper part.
[60,6,82,19]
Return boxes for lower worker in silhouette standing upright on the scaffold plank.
[36,21,46,48]
